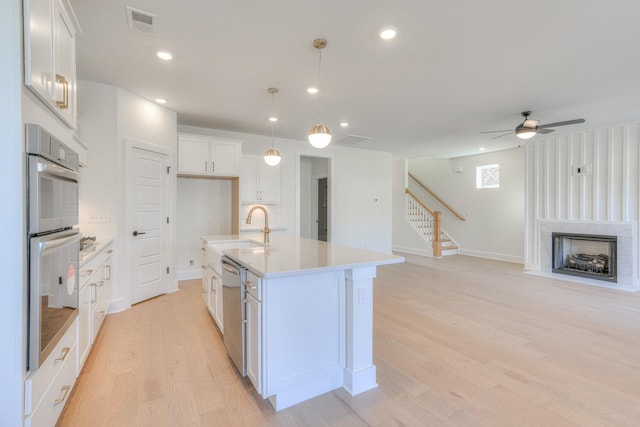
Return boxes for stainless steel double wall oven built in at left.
[26,124,81,371]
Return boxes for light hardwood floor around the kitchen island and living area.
[59,256,640,427]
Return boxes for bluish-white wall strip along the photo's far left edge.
[0,0,27,426]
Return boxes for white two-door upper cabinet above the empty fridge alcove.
[178,134,242,177]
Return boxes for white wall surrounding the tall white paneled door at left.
[78,80,177,311]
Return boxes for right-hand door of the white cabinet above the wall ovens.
[51,0,76,128]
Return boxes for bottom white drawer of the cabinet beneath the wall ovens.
[24,346,76,427]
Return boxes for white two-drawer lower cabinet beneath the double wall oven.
[24,320,78,427]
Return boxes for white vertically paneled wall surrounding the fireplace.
[525,122,640,281]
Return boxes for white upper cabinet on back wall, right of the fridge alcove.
[240,154,280,204]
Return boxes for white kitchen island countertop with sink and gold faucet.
[201,233,404,277]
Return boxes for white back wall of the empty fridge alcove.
[176,177,232,280]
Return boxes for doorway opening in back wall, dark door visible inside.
[300,156,331,242]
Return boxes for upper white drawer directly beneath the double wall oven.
[24,319,78,415]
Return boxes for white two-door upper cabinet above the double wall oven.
[23,0,80,129]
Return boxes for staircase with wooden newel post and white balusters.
[405,188,459,258]
